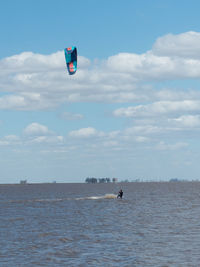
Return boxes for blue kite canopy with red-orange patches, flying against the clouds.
[64,46,77,75]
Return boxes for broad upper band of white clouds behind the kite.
[0,32,200,110]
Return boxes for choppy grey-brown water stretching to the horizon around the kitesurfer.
[0,182,200,267]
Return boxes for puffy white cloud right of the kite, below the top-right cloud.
[107,51,200,80]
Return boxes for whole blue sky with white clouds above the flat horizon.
[0,0,200,183]
